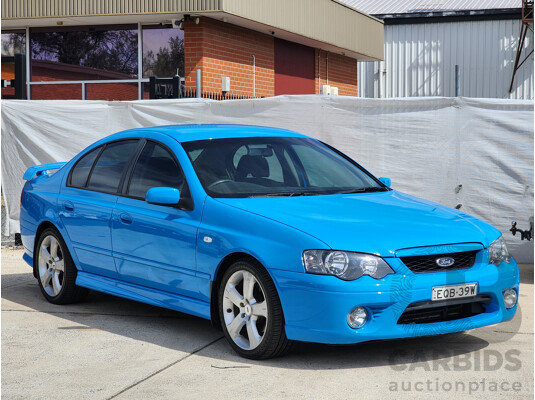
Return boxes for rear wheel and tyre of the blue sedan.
[34,228,89,304]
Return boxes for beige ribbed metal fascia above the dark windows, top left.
[2,0,221,19]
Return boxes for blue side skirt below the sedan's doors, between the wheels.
[76,271,210,320]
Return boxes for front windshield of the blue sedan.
[182,137,389,197]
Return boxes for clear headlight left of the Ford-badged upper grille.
[303,250,394,281]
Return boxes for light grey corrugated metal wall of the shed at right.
[359,20,533,100]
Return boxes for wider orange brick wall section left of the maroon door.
[184,17,275,97]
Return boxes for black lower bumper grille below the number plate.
[398,295,491,324]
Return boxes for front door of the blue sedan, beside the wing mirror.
[112,138,202,298]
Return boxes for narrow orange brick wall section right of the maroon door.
[315,49,358,96]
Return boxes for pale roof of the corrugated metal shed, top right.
[338,0,522,15]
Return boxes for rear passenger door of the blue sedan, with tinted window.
[58,139,139,278]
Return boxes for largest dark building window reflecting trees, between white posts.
[30,25,138,100]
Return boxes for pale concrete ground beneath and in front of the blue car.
[1,247,533,400]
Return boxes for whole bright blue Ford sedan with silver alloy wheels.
[20,125,519,359]
